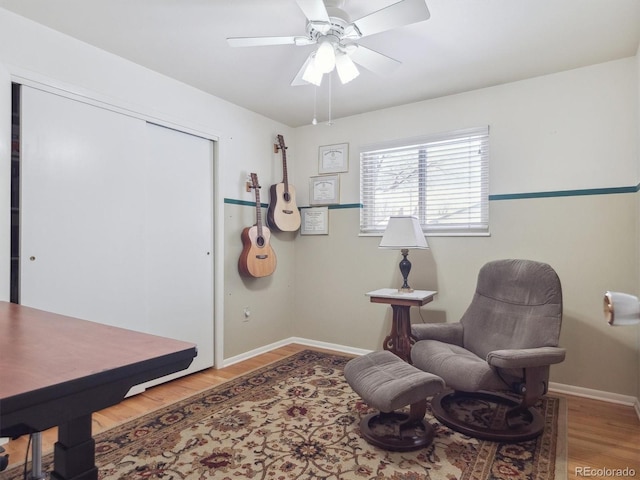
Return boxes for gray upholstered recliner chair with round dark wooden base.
[411,260,565,442]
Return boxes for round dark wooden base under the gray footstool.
[360,412,435,452]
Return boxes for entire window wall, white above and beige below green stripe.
[295,58,639,396]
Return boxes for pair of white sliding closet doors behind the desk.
[20,87,213,371]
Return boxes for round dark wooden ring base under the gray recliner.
[431,390,544,443]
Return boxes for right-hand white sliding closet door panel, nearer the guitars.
[145,124,213,368]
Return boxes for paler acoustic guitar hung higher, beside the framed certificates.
[267,135,300,232]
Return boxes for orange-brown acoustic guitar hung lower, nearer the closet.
[238,173,277,278]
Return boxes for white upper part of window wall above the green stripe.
[296,57,638,203]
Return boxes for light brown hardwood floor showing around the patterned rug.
[0,345,640,480]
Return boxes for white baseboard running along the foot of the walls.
[223,337,640,419]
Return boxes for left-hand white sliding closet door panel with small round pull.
[20,86,147,330]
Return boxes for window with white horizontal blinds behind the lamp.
[360,127,489,235]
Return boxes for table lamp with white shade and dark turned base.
[378,216,429,293]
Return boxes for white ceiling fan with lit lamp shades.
[227,0,430,86]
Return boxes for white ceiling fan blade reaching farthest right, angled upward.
[353,0,431,37]
